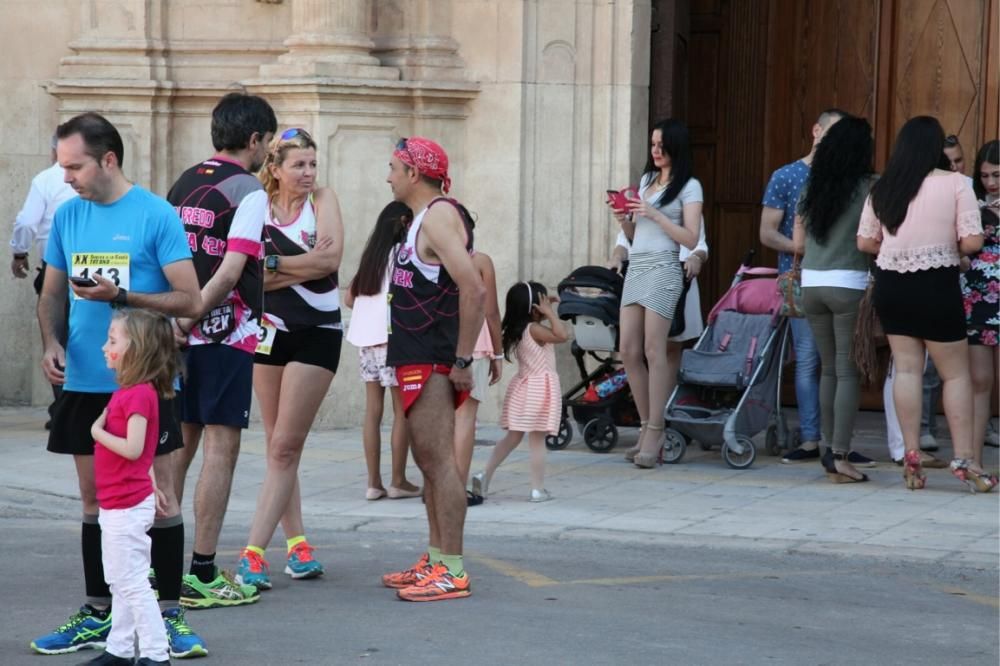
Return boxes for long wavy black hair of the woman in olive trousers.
[801,116,872,245]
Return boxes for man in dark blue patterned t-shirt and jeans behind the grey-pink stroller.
[760,109,871,465]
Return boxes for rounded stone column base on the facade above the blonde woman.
[260,0,399,80]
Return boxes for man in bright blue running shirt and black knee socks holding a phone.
[31,113,206,659]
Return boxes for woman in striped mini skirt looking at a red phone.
[608,119,703,469]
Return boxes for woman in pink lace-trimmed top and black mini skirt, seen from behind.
[858,116,997,492]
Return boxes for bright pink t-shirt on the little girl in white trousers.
[94,384,160,509]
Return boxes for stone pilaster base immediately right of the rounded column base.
[373,0,465,81]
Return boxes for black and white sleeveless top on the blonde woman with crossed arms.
[264,195,341,331]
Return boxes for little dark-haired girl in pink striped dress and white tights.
[472,282,569,502]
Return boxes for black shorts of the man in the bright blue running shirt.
[48,391,184,456]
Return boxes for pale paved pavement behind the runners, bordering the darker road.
[0,408,1000,568]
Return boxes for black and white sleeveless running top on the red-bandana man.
[386,197,472,366]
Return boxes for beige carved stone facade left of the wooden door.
[0,0,650,425]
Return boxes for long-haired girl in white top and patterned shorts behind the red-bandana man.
[344,201,420,501]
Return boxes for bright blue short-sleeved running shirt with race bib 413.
[45,185,191,393]
